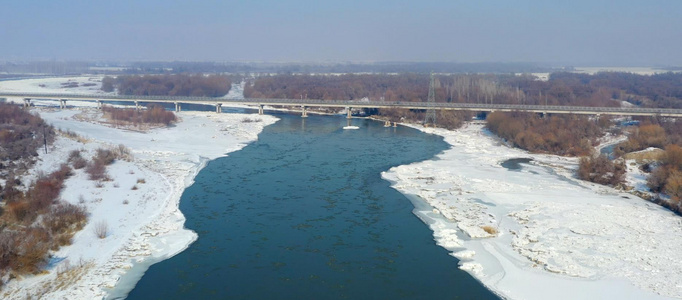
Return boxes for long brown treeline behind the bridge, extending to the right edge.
[244,72,682,108]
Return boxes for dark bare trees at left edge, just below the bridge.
[0,103,55,173]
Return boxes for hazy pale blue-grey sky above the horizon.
[0,0,682,66]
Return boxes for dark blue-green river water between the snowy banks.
[128,115,496,299]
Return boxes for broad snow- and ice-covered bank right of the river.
[383,124,682,299]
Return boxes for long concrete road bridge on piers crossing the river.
[0,91,682,118]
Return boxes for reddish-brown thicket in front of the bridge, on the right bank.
[486,112,610,156]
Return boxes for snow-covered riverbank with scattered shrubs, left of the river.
[2,108,277,299]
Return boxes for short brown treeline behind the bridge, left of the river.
[102,74,232,97]
